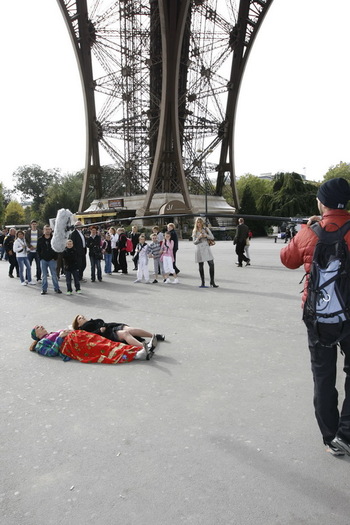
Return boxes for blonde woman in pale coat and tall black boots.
[192,217,219,288]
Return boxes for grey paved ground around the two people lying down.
[0,239,350,525]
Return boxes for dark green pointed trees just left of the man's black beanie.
[259,173,318,217]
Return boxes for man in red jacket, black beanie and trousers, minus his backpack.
[281,178,350,456]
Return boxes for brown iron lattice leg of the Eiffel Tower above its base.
[57,0,273,215]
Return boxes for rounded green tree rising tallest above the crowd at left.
[12,164,61,210]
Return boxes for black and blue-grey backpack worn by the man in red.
[303,221,350,346]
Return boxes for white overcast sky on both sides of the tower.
[0,0,350,187]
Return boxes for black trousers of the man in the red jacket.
[308,323,350,444]
